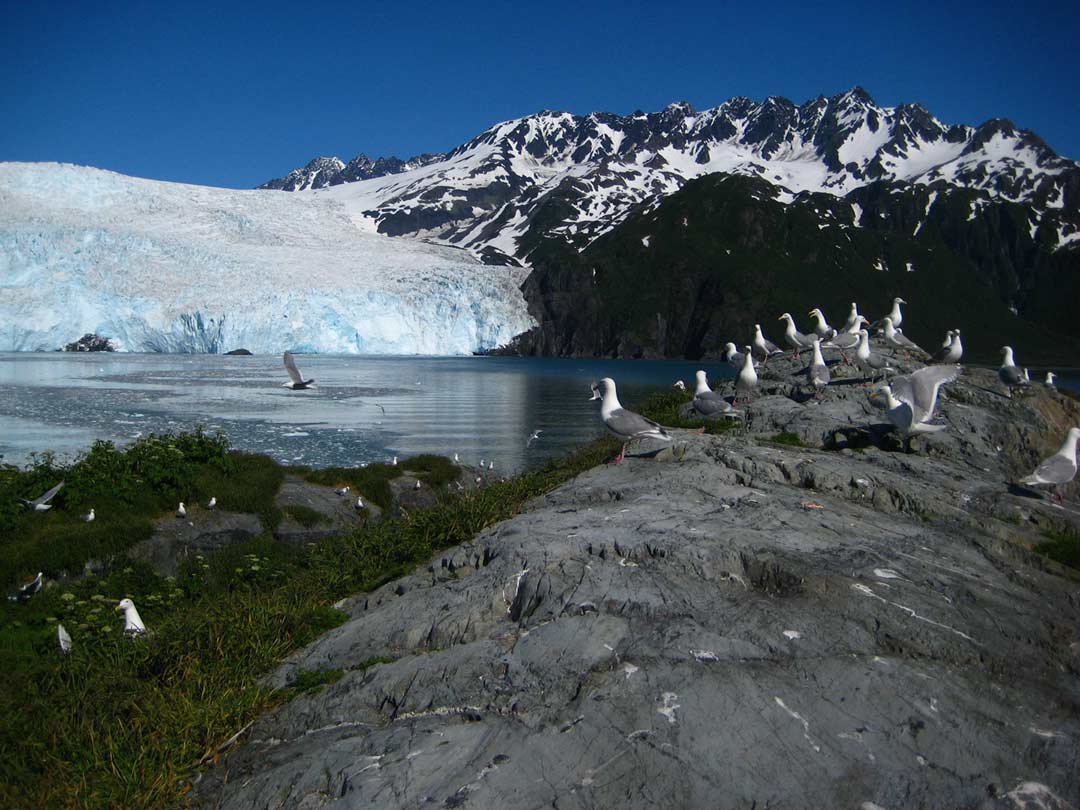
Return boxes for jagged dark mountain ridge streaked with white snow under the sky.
[264,87,1080,264]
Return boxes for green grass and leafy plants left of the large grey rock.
[0,438,618,809]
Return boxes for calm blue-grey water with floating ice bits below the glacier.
[0,353,726,472]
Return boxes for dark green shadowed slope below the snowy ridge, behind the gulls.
[507,175,1080,365]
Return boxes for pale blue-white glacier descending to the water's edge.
[0,163,535,354]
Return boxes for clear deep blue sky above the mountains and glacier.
[0,0,1080,188]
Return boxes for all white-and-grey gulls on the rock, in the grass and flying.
[8,306,1080,653]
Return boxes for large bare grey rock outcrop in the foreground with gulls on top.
[195,360,1080,810]
